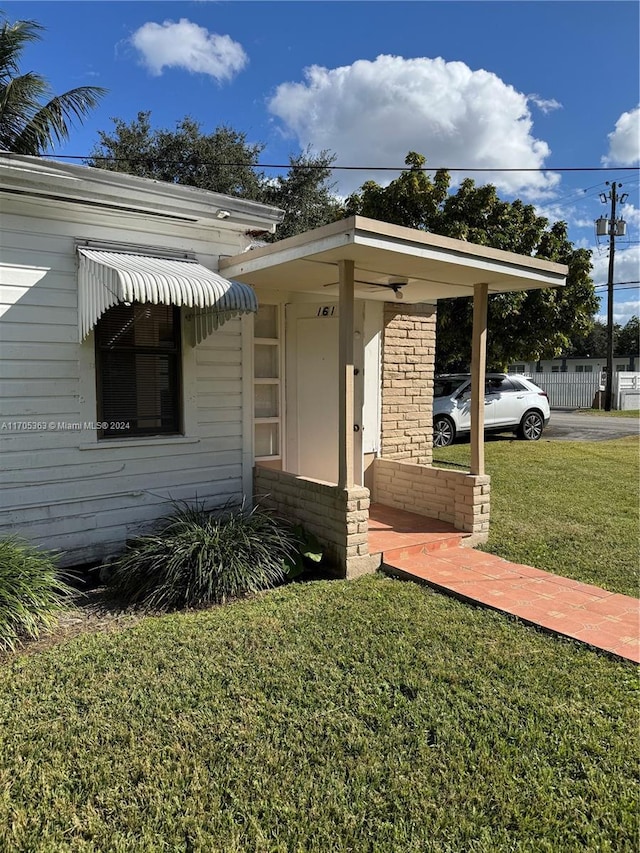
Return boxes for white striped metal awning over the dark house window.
[78,246,258,343]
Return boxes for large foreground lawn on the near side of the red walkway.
[0,572,638,853]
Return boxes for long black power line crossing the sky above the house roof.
[36,154,640,172]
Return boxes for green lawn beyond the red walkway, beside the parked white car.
[434,437,640,596]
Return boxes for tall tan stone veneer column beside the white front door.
[380,302,436,465]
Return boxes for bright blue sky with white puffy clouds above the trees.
[2,0,640,323]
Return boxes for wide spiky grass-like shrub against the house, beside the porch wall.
[109,506,296,610]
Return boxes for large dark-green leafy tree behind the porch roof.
[345,152,598,370]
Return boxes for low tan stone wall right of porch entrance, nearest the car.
[373,458,491,541]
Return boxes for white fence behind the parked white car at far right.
[531,371,640,409]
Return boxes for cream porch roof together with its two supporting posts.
[228,216,568,490]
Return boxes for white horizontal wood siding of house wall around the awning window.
[0,200,251,565]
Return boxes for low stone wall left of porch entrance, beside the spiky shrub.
[254,465,379,578]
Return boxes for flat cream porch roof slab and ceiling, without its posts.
[219,216,568,302]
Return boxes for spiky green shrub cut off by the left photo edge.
[0,538,72,651]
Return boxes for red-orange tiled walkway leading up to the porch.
[369,504,640,663]
